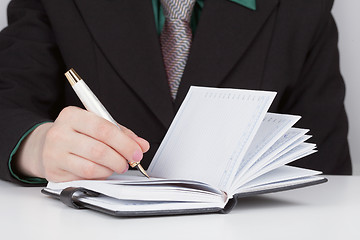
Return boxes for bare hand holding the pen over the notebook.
[15,107,149,182]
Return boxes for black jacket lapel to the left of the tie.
[74,0,174,127]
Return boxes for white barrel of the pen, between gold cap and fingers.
[72,80,119,127]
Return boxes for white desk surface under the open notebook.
[0,176,360,240]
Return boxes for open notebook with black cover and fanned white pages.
[42,87,326,216]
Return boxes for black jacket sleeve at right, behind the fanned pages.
[282,0,352,174]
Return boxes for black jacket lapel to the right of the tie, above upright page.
[175,0,278,108]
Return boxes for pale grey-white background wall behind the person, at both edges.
[0,0,360,175]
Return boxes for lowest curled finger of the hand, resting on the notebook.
[59,153,113,179]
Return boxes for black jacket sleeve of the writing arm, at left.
[0,0,65,184]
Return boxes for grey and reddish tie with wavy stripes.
[160,0,195,99]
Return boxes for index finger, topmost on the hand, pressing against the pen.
[59,107,143,162]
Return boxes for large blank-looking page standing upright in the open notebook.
[148,87,276,191]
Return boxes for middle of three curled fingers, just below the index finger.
[68,132,128,173]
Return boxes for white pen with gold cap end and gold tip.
[65,68,150,178]
